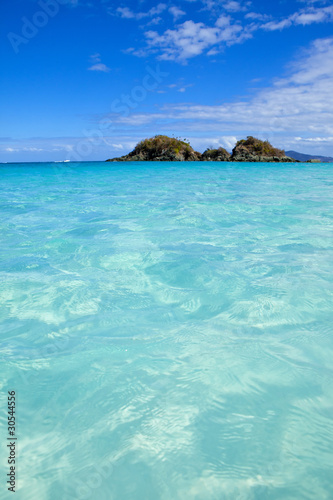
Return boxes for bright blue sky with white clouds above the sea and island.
[0,0,333,162]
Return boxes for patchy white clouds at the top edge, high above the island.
[116,0,333,63]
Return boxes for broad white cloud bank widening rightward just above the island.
[107,37,333,151]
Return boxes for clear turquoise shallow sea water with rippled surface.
[0,163,333,500]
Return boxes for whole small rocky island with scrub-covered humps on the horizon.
[106,135,298,163]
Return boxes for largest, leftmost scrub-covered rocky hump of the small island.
[107,135,201,161]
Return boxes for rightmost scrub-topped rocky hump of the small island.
[231,136,295,162]
